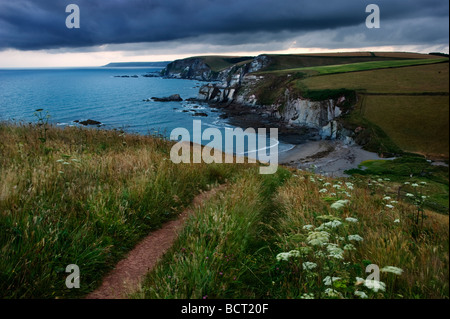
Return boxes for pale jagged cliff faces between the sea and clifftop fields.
[162,55,356,144]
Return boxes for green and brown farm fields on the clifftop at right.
[293,59,449,159]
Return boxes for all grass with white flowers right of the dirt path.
[131,170,449,299]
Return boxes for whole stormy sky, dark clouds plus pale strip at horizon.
[0,0,449,66]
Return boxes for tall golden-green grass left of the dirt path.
[0,124,253,298]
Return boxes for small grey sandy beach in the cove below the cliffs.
[278,140,386,177]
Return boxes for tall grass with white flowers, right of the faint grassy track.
[275,176,449,298]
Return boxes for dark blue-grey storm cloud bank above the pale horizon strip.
[0,0,449,50]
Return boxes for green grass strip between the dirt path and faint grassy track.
[134,172,263,299]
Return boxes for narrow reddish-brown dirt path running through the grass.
[86,185,226,299]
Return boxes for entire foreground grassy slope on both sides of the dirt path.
[0,125,448,298]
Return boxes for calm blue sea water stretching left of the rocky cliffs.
[0,68,292,158]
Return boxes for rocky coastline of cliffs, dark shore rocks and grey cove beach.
[162,55,390,176]
